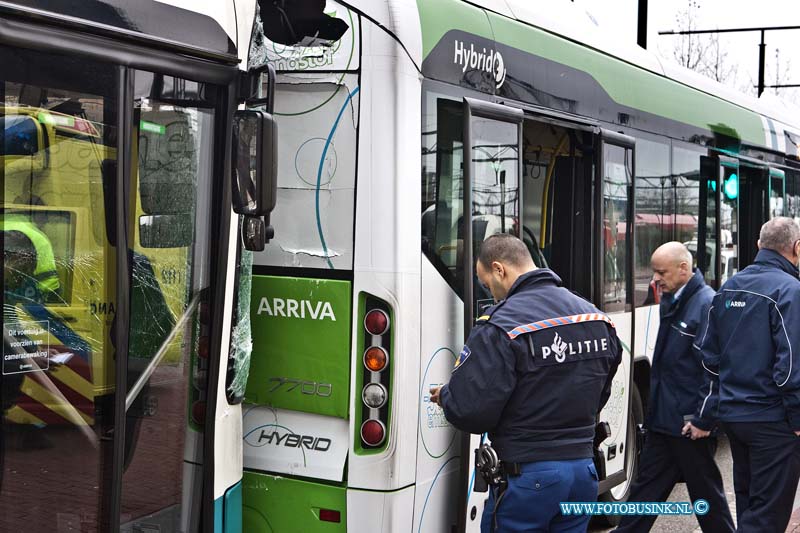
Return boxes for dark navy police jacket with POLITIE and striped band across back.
[440,269,622,463]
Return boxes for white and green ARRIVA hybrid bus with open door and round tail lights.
[243,0,800,532]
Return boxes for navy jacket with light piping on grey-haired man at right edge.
[698,249,800,431]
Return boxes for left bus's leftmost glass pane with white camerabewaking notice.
[0,47,117,531]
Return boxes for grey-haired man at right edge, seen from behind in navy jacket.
[693,217,800,532]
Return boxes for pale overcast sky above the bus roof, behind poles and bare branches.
[575,0,800,104]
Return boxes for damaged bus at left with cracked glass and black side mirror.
[0,0,282,533]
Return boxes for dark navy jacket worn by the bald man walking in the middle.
[646,270,714,437]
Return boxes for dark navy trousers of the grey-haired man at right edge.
[724,421,800,533]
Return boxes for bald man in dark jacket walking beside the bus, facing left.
[616,242,733,532]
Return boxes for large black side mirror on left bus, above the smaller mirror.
[232,110,278,216]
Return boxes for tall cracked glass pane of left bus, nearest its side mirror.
[120,71,217,531]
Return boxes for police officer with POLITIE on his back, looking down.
[431,234,622,533]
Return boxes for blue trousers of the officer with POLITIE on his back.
[481,459,597,533]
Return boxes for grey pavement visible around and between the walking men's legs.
[589,434,800,533]
